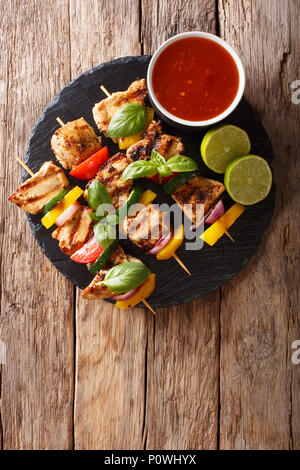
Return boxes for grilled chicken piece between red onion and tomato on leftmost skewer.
[52,206,93,256]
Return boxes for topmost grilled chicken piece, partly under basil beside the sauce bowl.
[93,78,147,136]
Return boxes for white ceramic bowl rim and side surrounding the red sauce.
[147,31,245,130]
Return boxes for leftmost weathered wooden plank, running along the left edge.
[0,0,74,449]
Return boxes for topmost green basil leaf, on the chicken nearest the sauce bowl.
[107,103,146,138]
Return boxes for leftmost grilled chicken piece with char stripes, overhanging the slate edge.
[9,162,69,214]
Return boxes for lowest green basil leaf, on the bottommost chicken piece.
[103,261,150,294]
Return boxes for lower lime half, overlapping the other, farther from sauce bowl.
[224,155,272,206]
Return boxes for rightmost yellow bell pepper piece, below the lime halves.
[200,204,245,246]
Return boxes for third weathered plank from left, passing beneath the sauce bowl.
[142,0,219,449]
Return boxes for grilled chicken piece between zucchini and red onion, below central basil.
[122,204,171,251]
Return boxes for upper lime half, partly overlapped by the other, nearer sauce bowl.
[200,124,251,173]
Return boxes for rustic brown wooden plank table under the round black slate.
[0,0,300,449]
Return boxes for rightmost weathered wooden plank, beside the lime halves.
[219,0,300,449]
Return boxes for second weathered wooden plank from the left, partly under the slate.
[70,0,149,449]
